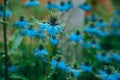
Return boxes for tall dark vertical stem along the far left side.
[3,0,9,80]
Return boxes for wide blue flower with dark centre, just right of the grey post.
[83,24,99,35]
